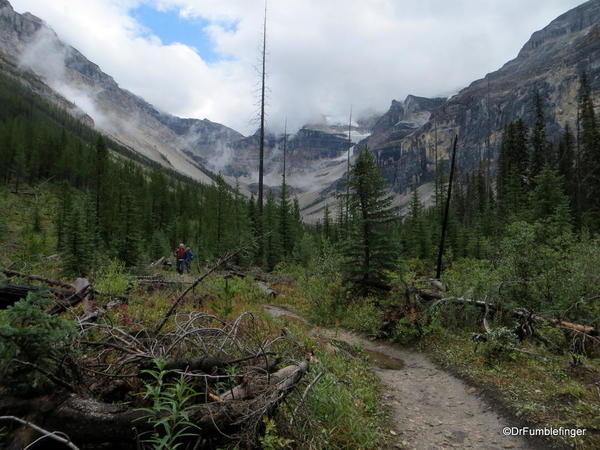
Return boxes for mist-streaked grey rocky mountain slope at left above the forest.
[0,0,242,182]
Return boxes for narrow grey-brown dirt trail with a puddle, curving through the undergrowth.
[265,305,535,450]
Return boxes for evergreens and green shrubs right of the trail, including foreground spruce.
[317,76,600,322]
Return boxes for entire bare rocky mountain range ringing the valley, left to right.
[0,0,600,220]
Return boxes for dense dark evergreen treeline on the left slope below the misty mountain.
[0,71,303,274]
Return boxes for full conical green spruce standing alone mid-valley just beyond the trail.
[344,147,397,295]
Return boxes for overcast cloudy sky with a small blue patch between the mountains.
[10,0,583,134]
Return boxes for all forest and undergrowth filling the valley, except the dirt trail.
[0,60,600,449]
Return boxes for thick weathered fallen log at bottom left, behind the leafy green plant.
[0,362,309,448]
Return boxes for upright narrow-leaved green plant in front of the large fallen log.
[139,360,200,450]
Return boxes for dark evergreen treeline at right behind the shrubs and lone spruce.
[318,74,600,262]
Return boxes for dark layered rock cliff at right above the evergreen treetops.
[369,0,600,197]
